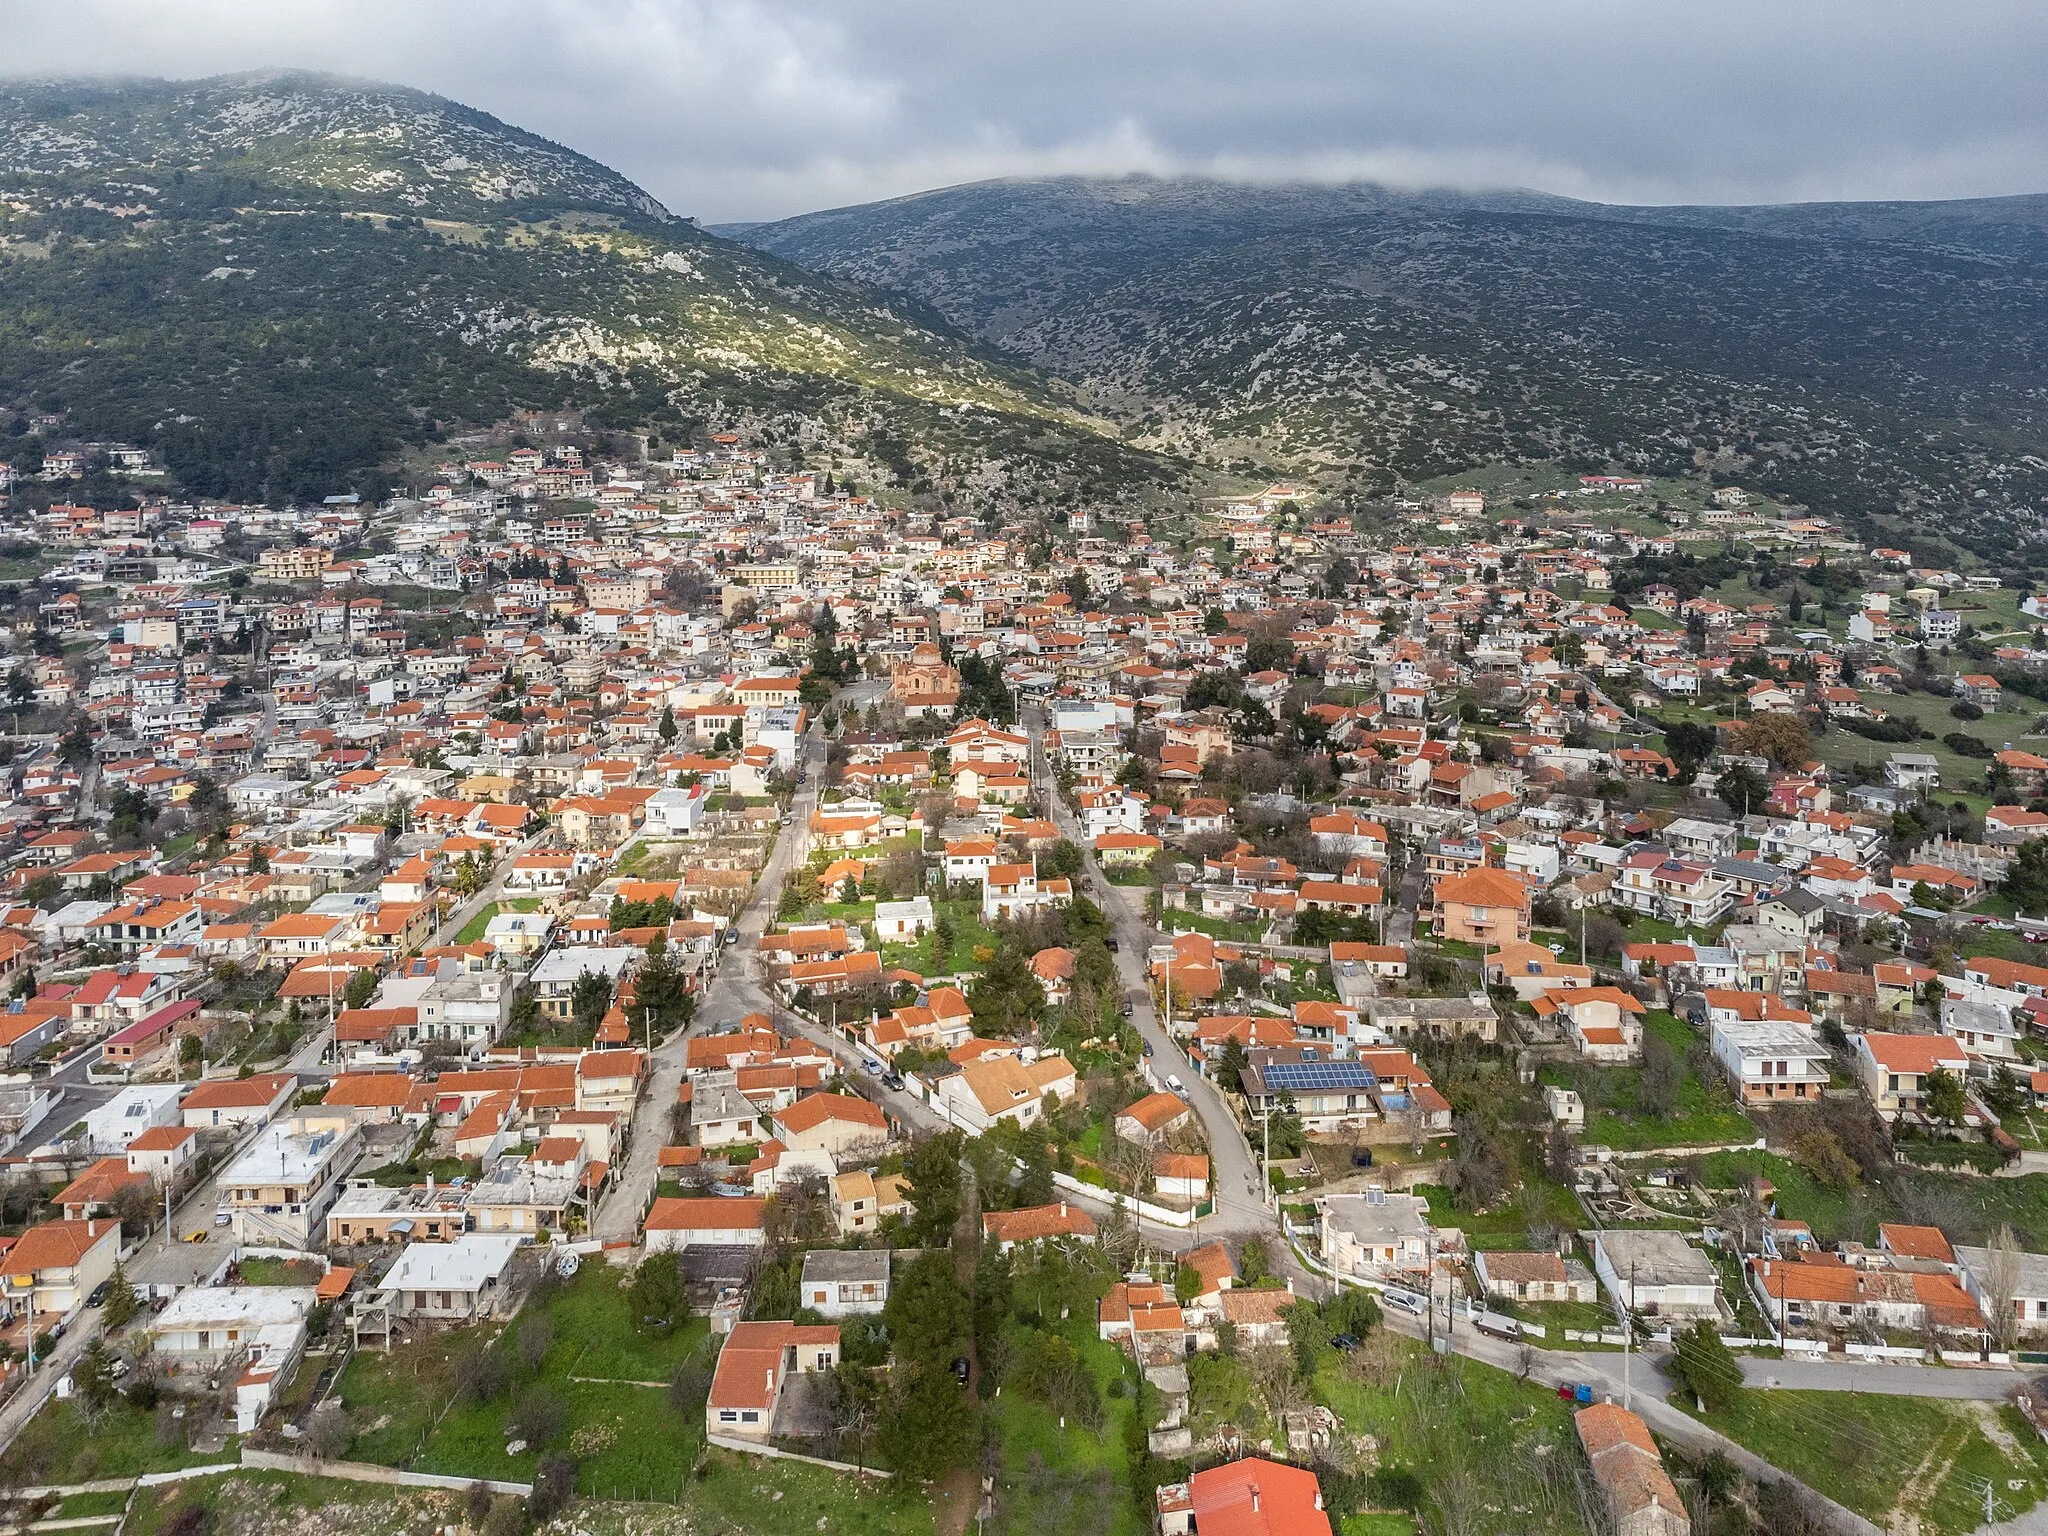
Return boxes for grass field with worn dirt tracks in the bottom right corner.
[1673,1391,2048,1536]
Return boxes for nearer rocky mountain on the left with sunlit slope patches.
[0,74,1176,506]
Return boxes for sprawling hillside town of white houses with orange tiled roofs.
[0,430,2048,1536]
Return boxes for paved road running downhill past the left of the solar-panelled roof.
[1024,709,1278,1239]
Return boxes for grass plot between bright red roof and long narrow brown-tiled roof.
[1315,1333,1585,1536]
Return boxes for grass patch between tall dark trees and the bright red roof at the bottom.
[985,1315,1151,1536]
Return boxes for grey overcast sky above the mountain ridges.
[0,0,2048,221]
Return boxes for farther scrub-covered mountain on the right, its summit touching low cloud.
[731,176,2048,565]
